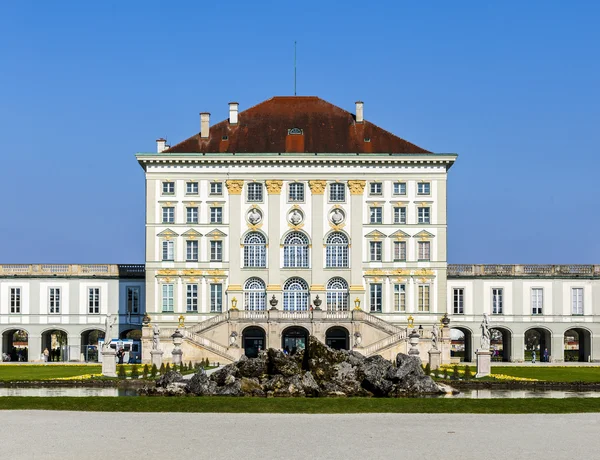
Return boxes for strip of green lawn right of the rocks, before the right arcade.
[492,364,600,382]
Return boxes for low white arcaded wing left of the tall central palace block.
[0,264,146,362]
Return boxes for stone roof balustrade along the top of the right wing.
[448,264,600,278]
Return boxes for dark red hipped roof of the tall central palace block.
[165,96,431,153]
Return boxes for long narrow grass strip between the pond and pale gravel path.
[0,396,600,414]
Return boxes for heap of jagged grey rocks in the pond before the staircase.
[140,337,446,397]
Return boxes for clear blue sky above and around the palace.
[0,1,600,263]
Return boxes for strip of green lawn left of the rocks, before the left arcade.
[0,364,102,382]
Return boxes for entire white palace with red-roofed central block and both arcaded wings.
[0,96,600,362]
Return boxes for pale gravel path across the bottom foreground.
[0,411,600,460]
